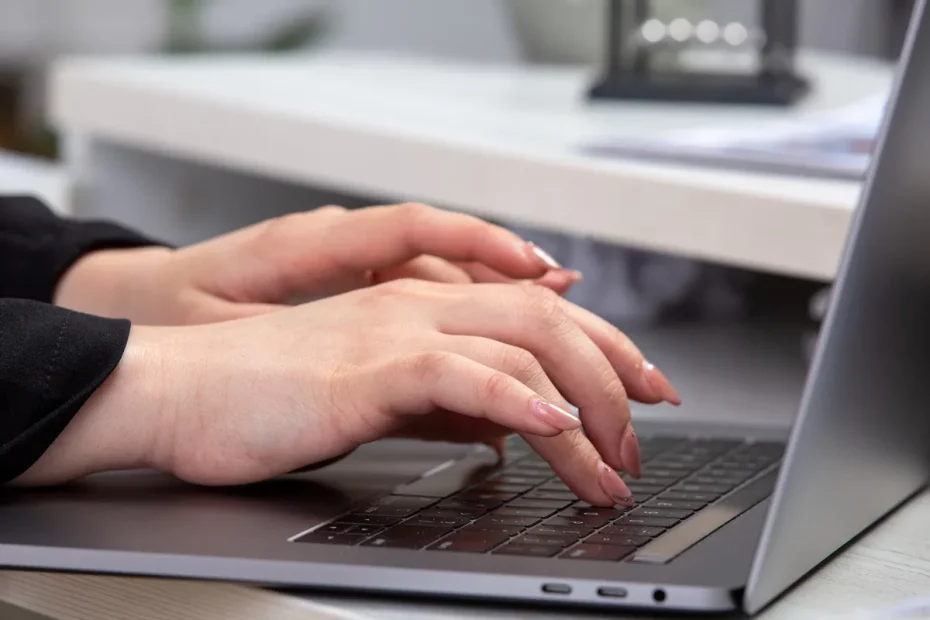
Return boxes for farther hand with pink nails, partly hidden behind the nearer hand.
[55,204,580,325]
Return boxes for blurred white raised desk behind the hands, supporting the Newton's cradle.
[51,56,892,280]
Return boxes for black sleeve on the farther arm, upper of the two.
[0,196,159,302]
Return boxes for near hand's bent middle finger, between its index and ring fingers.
[434,284,641,476]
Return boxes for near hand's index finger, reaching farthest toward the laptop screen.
[564,303,681,405]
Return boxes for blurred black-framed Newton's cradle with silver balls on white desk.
[590,0,808,105]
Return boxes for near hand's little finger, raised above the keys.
[380,351,581,437]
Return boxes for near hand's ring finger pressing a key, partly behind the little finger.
[442,336,632,506]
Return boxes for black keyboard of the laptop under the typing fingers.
[294,436,784,564]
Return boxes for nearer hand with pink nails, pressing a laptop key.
[18,280,678,506]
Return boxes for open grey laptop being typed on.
[0,1,930,613]
